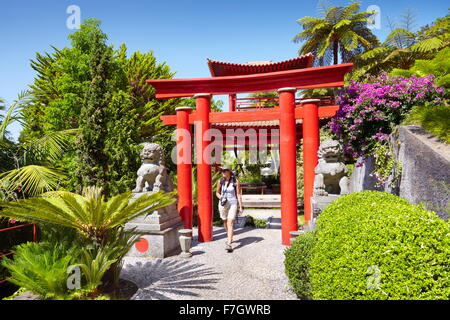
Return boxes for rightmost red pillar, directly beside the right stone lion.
[302,99,320,224]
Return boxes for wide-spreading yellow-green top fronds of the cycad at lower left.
[0,187,175,244]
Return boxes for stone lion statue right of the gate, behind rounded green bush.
[314,140,349,196]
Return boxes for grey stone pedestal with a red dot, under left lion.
[125,192,184,258]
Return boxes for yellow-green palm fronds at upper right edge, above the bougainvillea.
[351,14,450,80]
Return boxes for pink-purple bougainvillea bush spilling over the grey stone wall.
[329,73,444,157]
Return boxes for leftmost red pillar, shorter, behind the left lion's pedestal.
[175,107,192,229]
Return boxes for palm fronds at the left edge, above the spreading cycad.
[0,91,77,196]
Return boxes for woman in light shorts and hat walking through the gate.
[216,167,243,252]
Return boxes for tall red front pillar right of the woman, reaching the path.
[278,88,298,245]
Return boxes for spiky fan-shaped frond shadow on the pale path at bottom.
[121,259,220,300]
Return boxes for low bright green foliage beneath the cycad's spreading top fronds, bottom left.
[3,225,134,299]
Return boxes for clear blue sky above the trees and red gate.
[0,0,450,136]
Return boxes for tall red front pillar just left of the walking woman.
[194,93,213,242]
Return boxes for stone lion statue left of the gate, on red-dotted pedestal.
[133,143,173,192]
